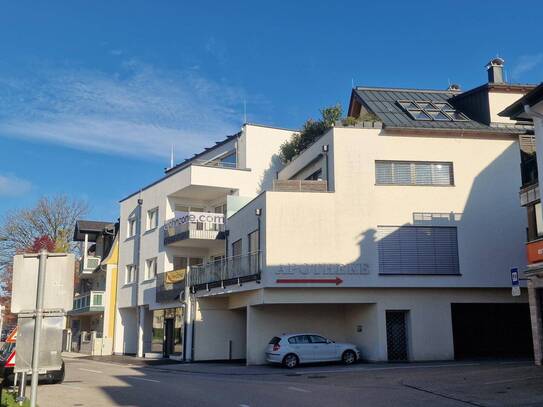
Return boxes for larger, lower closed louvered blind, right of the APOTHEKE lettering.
[377,226,460,275]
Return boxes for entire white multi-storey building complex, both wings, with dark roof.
[115,61,532,364]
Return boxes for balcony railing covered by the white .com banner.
[163,212,224,244]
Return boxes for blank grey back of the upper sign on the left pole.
[11,253,75,314]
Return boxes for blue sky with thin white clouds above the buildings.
[0,0,543,220]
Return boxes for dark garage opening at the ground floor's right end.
[451,304,533,359]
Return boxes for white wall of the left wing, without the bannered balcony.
[115,124,292,355]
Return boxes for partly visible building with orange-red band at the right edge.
[500,83,543,365]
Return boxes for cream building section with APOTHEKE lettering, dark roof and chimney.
[182,59,534,364]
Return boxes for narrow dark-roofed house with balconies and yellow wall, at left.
[68,220,119,355]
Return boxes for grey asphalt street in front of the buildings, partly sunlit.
[30,358,543,407]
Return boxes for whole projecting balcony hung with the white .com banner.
[163,212,224,248]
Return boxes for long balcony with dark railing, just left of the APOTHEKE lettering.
[189,252,261,292]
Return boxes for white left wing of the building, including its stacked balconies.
[114,124,292,358]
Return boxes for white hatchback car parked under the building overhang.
[266,333,360,369]
